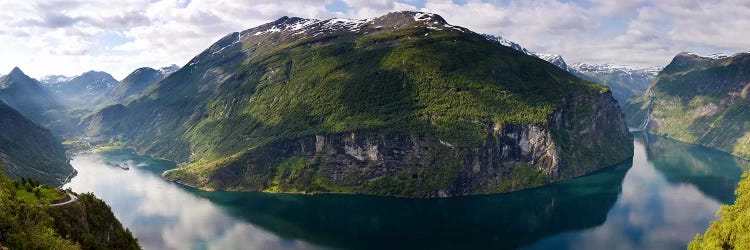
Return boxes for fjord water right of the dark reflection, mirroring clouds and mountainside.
[526,134,742,249]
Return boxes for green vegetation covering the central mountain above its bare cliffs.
[87,13,632,194]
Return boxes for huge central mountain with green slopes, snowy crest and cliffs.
[87,12,632,197]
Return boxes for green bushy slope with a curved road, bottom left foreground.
[0,171,139,249]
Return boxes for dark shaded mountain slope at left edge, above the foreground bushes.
[0,101,75,186]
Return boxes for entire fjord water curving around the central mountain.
[66,133,746,249]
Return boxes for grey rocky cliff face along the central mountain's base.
[165,90,633,197]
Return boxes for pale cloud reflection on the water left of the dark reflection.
[66,152,322,249]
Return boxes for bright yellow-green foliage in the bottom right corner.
[688,173,750,250]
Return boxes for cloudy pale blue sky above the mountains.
[0,0,750,79]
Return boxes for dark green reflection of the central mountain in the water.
[189,161,630,249]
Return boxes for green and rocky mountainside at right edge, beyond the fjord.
[625,53,750,158]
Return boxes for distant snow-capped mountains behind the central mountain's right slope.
[484,34,662,106]
